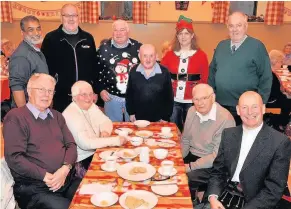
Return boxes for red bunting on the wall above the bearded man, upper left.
[11,2,81,17]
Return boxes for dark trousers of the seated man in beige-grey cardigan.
[183,152,211,200]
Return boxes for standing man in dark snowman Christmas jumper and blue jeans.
[97,20,141,122]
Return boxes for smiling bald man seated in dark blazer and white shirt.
[207,91,291,209]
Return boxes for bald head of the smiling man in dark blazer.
[236,91,266,129]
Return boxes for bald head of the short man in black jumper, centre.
[138,44,157,70]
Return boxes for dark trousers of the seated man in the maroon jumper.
[13,172,81,209]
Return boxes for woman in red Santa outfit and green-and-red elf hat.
[161,15,208,131]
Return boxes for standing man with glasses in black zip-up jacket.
[41,4,97,112]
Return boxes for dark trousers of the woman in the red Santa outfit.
[171,102,193,132]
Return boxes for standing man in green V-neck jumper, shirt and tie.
[208,12,272,125]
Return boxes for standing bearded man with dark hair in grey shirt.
[9,16,49,108]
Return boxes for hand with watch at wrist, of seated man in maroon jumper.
[50,165,70,192]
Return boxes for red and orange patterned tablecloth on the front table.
[69,122,193,209]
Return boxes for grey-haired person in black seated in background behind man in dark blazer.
[266,50,291,129]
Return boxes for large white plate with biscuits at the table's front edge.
[119,190,158,209]
